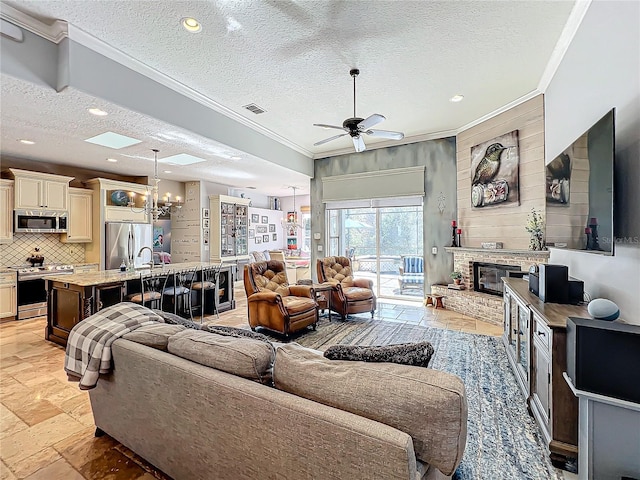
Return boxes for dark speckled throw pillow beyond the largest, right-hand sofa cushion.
[324,342,433,367]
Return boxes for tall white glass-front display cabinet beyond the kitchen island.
[209,195,250,263]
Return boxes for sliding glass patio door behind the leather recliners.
[327,202,424,300]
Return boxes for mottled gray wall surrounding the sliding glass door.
[311,137,457,291]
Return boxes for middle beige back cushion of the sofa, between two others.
[168,330,275,383]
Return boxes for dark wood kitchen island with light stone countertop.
[45,262,236,346]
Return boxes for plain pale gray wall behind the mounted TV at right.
[544,0,640,324]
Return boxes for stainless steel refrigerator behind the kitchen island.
[104,222,153,270]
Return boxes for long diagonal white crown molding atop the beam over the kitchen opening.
[68,24,313,158]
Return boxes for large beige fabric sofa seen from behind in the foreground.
[90,324,467,480]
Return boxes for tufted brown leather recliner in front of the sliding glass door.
[317,257,376,320]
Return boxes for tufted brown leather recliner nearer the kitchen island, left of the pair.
[244,260,318,336]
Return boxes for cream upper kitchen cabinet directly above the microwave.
[9,168,73,210]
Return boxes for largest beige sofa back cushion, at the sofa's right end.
[273,344,467,475]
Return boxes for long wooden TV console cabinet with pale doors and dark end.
[502,278,589,466]
